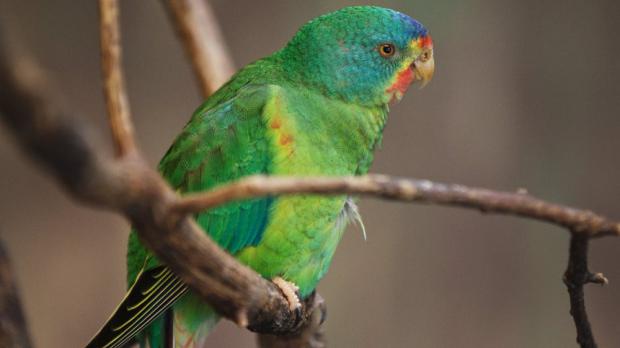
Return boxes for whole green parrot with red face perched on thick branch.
[87,6,434,348]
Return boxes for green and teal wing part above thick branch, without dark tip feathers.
[159,85,279,254]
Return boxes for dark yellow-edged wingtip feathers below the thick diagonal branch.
[86,266,187,348]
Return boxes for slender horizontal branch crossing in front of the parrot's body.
[174,175,620,237]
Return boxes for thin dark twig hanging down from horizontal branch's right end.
[564,234,607,348]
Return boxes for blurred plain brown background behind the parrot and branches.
[0,0,620,348]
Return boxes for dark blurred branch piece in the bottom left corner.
[0,242,32,348]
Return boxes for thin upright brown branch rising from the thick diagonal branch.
[99,0,136,156]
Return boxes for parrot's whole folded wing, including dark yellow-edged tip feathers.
[87,85,279,348]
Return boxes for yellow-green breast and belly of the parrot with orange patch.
[238,85,385,296]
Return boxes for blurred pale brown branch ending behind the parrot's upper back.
[162,0,235,98]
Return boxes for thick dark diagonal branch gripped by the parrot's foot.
[0,34,313,334]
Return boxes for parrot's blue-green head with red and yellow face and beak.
[280,6,435,105]
